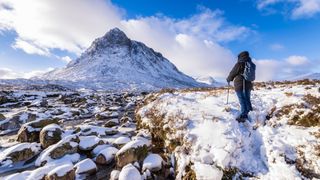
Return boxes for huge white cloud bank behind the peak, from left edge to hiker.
[0,0,252,77]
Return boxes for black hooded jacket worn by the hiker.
[227,52,253,91]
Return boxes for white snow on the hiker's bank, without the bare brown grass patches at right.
[138,82,320,179]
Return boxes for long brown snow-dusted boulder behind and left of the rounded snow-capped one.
[17,118,59,142]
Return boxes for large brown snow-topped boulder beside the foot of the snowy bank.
[116,137,151,167]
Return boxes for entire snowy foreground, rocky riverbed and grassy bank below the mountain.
[0,81,320,180]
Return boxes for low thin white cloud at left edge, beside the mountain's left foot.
[0,68,53,79]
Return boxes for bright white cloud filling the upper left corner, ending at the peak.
[0,0,121,54]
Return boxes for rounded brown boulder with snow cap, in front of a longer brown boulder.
[40,124,63,149]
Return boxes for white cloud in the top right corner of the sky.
[257,0,320,19]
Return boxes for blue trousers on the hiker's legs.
[236,89,252,116]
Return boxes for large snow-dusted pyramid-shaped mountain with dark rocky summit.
[37,28,205,90]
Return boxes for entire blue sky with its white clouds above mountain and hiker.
[0,0,320,80]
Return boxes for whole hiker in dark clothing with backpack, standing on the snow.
[227,51,256,122]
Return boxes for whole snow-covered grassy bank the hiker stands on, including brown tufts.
[138,82,320,179]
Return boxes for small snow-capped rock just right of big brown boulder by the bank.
[142,154,163,172]
